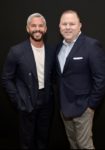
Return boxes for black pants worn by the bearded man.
[19,89,52,150]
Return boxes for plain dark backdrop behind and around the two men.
[0,0,105,150]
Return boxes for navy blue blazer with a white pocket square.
[56,34,105,117]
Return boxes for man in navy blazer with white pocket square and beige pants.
[56,10,105,149]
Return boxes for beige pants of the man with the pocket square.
[61,108,95,149]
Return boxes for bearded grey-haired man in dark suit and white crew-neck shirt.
[2,13,54,150]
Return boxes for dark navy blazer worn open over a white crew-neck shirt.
[2,40,55,112]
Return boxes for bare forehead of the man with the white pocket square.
[60,13,79,22]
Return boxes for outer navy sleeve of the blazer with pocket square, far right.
[89,42,105,109]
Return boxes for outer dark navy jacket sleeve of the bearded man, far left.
[2,49,19,104]
